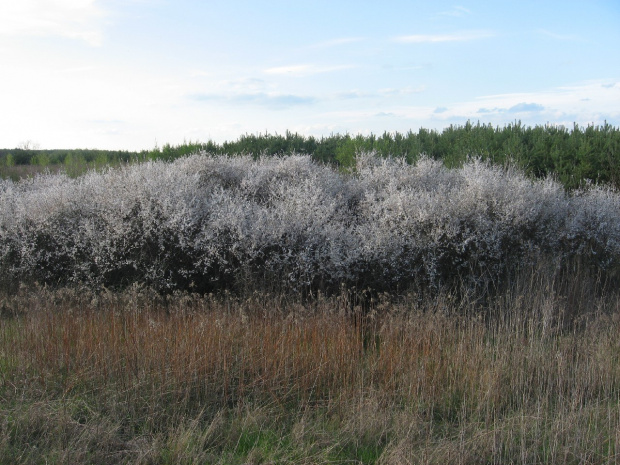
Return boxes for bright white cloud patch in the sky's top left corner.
[0,0,105,45]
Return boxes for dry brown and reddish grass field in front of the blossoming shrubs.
[0,276,620,464]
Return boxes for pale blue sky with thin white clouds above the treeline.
[0,0,620,150]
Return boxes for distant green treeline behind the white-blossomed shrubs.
[0,122,620,189]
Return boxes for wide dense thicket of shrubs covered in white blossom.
[0,154,620,292]
